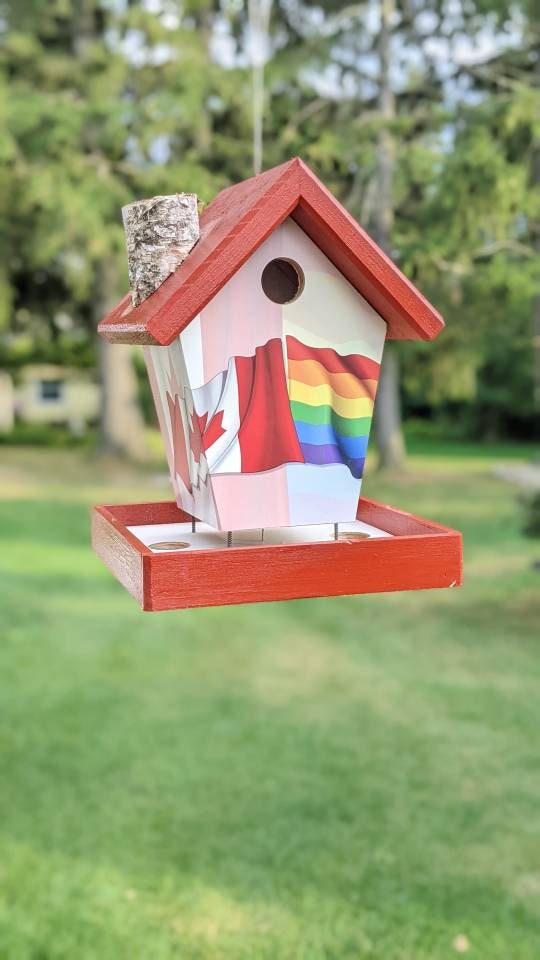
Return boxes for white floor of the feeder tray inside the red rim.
[127,520,392,553]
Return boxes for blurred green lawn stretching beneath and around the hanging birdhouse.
[0,447,540,960]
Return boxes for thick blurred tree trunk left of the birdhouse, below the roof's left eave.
[94,264,147,460]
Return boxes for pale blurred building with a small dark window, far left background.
[0,364,101,434]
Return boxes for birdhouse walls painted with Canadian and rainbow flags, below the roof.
[145,219,386,530]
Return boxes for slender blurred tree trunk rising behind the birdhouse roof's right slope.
[374,0,405,470]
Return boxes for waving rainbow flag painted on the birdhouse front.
[286,336,379,479]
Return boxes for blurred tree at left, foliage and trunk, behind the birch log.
[0,0,248,456]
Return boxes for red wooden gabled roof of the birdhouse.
[99,157,444,344]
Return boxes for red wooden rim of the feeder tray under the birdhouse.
[92,499,462,610]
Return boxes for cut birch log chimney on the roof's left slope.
[122,193,199,307]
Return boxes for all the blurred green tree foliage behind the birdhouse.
[0,0,540,435]
